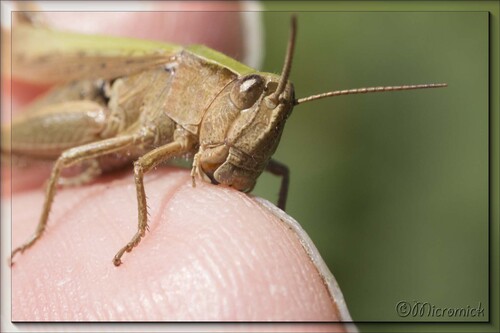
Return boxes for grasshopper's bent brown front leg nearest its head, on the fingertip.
[113,129,195,266]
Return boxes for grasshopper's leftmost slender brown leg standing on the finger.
[11,136,136,265]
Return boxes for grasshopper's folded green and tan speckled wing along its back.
[12,24,182,83]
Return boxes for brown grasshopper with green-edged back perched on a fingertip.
[2,16,446,266]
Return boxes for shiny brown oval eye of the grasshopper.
[229,75,265,110]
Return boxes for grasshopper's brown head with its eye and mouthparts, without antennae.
[198,73,295,191]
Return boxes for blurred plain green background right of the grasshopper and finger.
[254,2,488,322]
